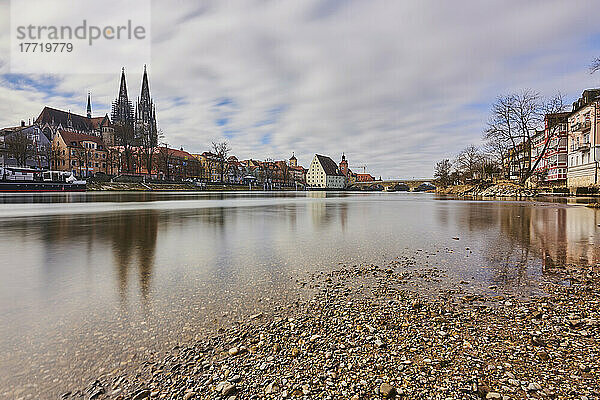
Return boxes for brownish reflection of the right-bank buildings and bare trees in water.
[436,201,600,288]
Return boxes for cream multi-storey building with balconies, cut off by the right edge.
[567,89,600,188]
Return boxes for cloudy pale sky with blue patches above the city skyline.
[0,0,600,178]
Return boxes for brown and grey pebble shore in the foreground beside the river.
[59,259,600,400]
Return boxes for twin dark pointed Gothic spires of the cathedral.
[111,65,158,146]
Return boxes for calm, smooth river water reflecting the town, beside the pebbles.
[0,192,600,398]
